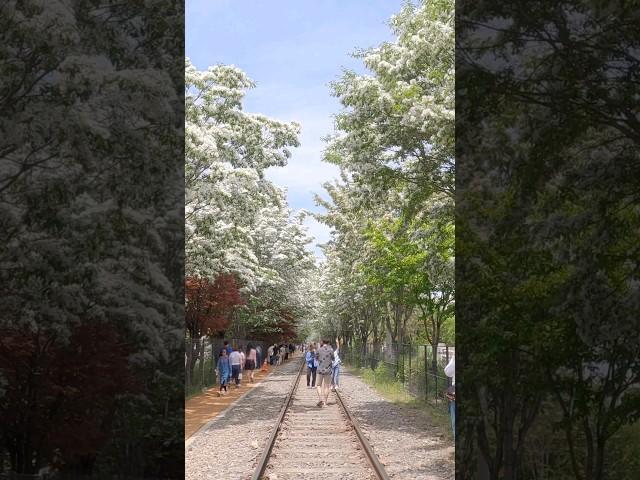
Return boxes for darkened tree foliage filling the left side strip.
[0,0,183,476]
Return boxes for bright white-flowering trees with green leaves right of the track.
[317,1,455,356]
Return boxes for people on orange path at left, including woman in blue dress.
[216,340,262,395]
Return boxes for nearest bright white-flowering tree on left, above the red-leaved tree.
[185,59,299,289]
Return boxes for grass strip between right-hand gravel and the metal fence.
[346,364,453,442]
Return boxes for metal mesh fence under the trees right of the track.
[340,343,455,409]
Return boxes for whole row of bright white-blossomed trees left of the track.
[185,59,314,348]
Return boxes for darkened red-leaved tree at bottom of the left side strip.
[0,323,140,473]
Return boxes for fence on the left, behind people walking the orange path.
[184,337,276,398]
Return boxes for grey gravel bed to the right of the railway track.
[340,372,455,480]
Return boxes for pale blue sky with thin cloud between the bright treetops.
[186,0,403,258]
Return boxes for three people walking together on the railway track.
[305,340,342,407]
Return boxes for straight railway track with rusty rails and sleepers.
[251,361,389,480]
